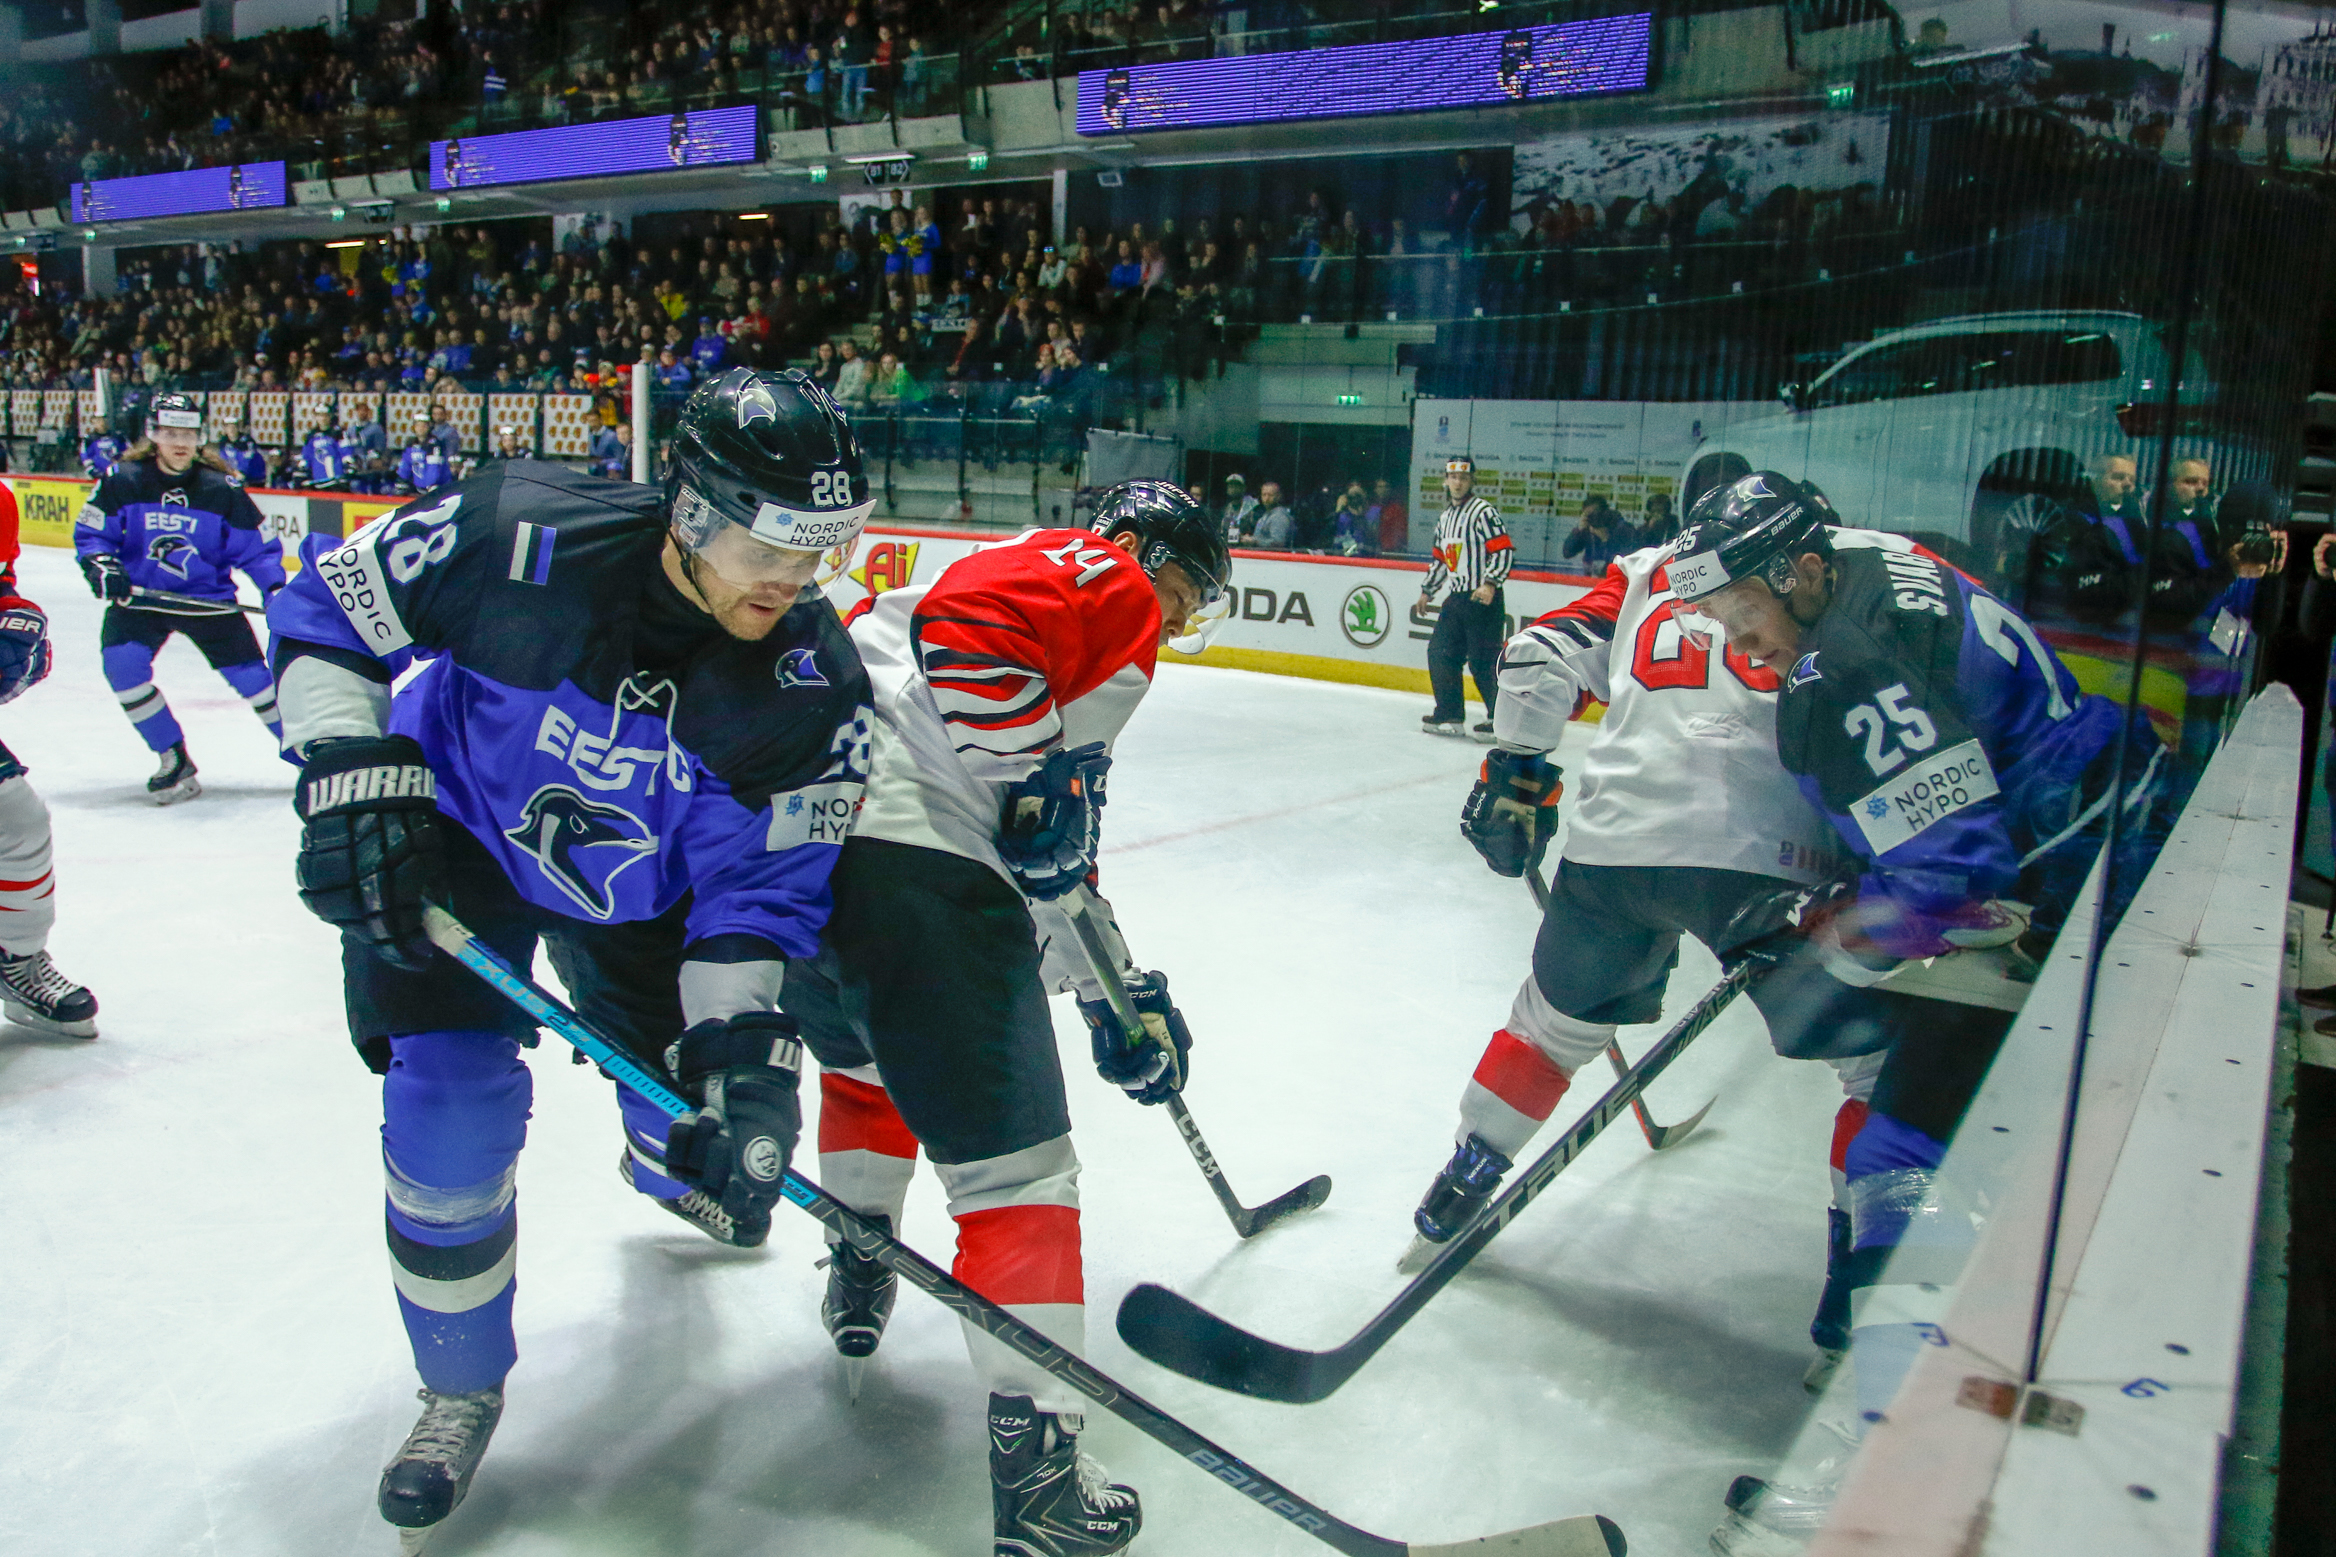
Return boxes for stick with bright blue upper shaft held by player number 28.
[423,903,1628,1557]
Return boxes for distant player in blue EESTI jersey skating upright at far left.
[72,392,285,805]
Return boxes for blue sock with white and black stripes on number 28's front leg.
[381,1032,533,1394]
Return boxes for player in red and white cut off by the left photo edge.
[0,486,98,1039]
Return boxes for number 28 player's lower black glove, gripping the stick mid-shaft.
[666,1011,804,1247]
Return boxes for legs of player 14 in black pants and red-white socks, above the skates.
[780,838,1086,1412]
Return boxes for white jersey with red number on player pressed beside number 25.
[1493,546,1838,885]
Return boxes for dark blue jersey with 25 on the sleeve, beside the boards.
[1775,530,2123,957]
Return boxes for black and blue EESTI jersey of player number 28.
[269,460,871,957]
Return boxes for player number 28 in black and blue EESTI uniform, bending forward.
[269,369,869,1550]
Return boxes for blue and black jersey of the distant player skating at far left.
[72,460,285,600]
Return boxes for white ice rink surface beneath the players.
[0,549,1838,1557]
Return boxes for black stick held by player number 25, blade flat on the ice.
[1119,955,1771,1405]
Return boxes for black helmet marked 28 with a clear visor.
[666,366,876,571]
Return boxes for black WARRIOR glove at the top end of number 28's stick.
[292,735,446,971]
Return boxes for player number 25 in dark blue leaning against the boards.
[1668,472,2170,1555]
